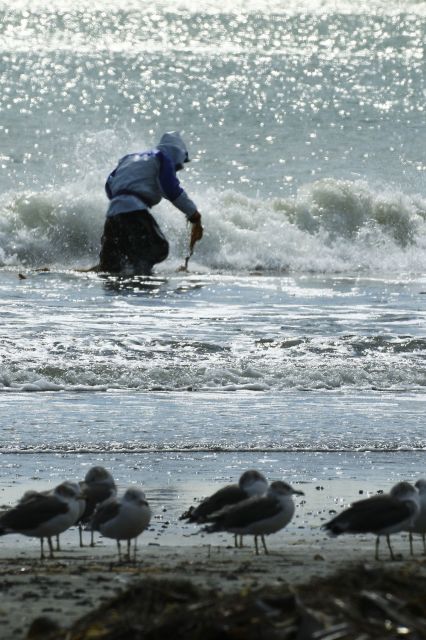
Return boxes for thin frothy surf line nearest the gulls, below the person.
[0,358,426,395]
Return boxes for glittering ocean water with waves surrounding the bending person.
[0,0,426,544]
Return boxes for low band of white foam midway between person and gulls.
[0,350,426,393]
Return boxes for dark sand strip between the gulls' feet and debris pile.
[0,532,426,640]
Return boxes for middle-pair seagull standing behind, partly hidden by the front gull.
[180,469,268,546]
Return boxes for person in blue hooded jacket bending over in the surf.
[97,131,203,275]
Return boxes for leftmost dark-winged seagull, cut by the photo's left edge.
[0,481,84,560]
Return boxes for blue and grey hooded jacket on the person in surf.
[105,131,197,219]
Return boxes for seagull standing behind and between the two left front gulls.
[78,466,117,547]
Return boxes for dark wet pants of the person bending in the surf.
[99,211,169,275]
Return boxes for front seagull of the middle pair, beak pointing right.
[203,480,305,555]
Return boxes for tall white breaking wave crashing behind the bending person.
[0,178,426,273]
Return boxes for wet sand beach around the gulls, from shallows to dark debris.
[0,456,426,640]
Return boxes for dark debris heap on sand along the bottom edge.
[27,565,426,640]
